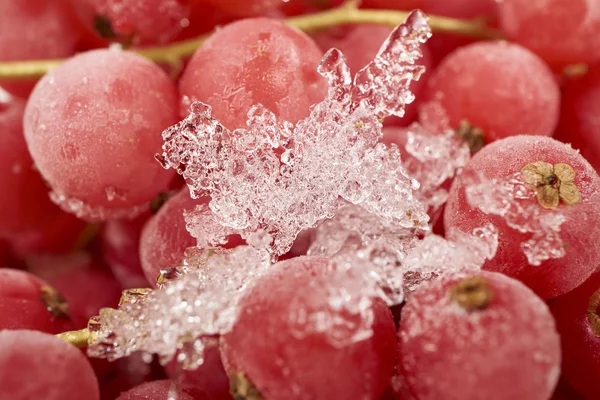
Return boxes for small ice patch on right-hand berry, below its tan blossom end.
[462,172,565,265]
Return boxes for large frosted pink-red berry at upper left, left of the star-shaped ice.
[24,50,177,220]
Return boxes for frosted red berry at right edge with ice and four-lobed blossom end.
[444,136,600,299]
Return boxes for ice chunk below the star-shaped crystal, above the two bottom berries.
[308,205,498,305]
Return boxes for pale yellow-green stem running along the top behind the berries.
[0,2,503,80]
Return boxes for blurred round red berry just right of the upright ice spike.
[420,41,560,143]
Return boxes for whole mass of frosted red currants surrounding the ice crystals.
[0,0,600,400]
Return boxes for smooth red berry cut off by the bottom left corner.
[0,330,100,400]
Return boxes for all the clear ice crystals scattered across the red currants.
[88,12,560,368]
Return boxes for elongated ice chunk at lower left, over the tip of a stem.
[88,246,271,369]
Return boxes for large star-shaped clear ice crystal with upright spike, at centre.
[159,12,431,255]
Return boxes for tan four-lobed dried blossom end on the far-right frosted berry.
[521,161,581,210]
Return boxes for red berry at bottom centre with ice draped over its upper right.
[221,257,396,400]
